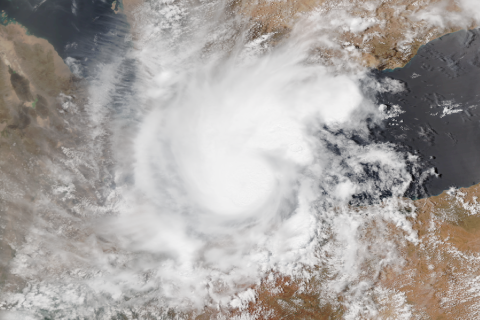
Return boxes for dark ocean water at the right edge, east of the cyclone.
[373,29,480,195]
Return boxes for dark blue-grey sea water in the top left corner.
[0,0,129,77]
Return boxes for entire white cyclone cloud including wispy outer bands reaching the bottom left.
[3,2,462,319]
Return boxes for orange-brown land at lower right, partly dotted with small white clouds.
[218,185,480,319]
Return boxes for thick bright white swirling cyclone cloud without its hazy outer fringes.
[99,0,418,305]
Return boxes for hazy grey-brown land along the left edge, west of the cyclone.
[0,23,109,298]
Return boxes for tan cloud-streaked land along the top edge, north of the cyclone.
[122,0,476,70]
